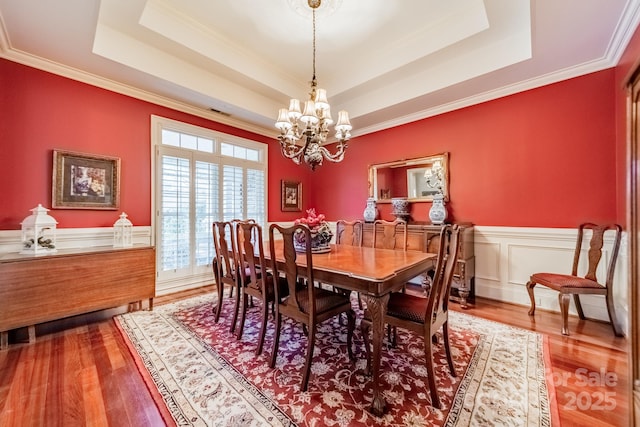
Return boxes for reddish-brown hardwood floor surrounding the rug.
[0,286,629,427]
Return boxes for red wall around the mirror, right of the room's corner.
[315,69,620,227]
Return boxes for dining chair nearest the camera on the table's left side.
[269,224,356,391]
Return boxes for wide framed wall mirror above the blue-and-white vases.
[369,153,449,203]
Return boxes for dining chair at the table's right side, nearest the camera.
[360,224,460,408]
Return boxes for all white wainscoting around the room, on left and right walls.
[0,222,629,333]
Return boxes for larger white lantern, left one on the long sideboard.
[20,204,58,255]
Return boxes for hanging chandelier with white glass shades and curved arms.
[276,0,352,170]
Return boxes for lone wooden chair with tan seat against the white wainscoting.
[527,223,623,337]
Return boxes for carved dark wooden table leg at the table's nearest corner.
[363,294,389,417]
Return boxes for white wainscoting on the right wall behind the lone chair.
[474,226,629,333]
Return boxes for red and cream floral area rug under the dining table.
[116,295,558,427]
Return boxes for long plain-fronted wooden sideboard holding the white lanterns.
[0,246,156,349]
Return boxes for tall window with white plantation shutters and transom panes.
[152,116,267,290]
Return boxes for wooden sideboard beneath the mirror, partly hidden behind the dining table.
[362,222,475,308]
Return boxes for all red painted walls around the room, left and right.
[0,48,640,229]
